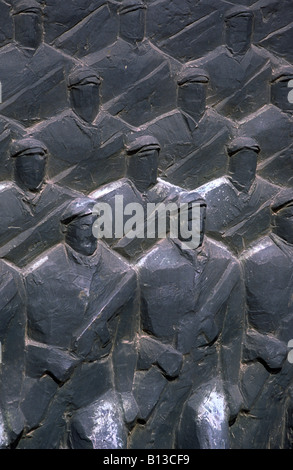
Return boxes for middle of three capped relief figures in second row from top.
[142,65,235,189]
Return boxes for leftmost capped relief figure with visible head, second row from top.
[29,65,130,192]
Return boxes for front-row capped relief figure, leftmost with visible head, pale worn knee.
[20,197,136,449]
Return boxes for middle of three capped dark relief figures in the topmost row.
[84,0,180,126]
